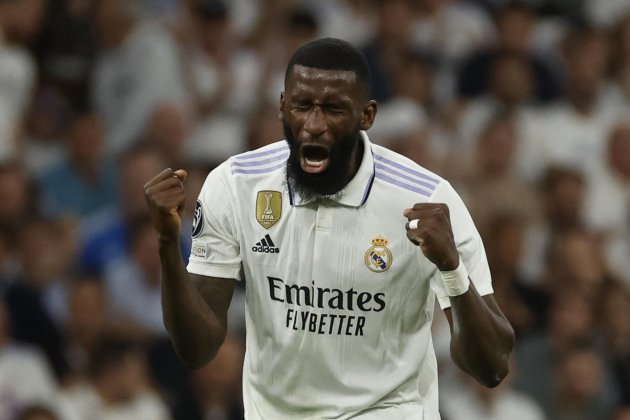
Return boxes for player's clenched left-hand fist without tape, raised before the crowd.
[144,168,188,240]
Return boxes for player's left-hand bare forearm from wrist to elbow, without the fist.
[160,240,226,368]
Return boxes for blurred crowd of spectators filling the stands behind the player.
[0,0,630,420]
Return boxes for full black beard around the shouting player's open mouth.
[282,121,361,201]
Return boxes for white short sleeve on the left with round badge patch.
[187,163,242,280]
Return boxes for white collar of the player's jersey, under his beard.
[289,131,375,207]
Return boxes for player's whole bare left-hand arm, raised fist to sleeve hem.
[144,169,235,368]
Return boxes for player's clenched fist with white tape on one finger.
[403,203,459,271]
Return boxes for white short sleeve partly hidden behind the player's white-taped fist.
[431,181,494,309]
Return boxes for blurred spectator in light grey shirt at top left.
[92,0,186,154]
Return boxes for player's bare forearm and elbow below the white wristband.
[450,283,514,387]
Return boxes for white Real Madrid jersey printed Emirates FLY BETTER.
[188,133,492,420]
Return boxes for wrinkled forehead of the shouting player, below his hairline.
[285,65,361,98]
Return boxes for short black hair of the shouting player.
[284,38,370,93]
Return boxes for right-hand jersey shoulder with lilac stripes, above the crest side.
[372,144,448,197]
